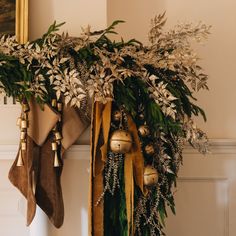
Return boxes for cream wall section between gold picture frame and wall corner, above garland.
[29,0,107,39]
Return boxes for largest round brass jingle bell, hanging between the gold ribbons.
[110,130,132,154]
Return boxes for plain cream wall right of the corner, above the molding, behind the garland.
[108,0,236,138]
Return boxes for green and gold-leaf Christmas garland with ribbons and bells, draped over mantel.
[0,14,210,236]
